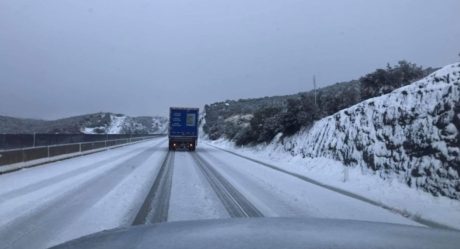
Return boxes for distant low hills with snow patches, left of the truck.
[0,113,168,134]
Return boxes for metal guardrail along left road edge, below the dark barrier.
[0,136,162,167]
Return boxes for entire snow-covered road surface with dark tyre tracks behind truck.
[0,138,423,249]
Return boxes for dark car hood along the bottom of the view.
[53,218,460,249]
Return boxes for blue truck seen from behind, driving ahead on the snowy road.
[168,107,199,151]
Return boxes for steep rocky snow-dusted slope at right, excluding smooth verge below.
[276,63,460,199]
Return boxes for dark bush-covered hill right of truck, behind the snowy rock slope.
[203,60,436,145]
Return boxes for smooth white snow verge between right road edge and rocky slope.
[210,140,460,229]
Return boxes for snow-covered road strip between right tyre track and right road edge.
[200,146,418,225]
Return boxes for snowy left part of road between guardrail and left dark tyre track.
[0,138,165,248]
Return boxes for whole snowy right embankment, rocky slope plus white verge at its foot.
[208,63,460,228]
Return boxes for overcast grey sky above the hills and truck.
[0,0,460,119]
